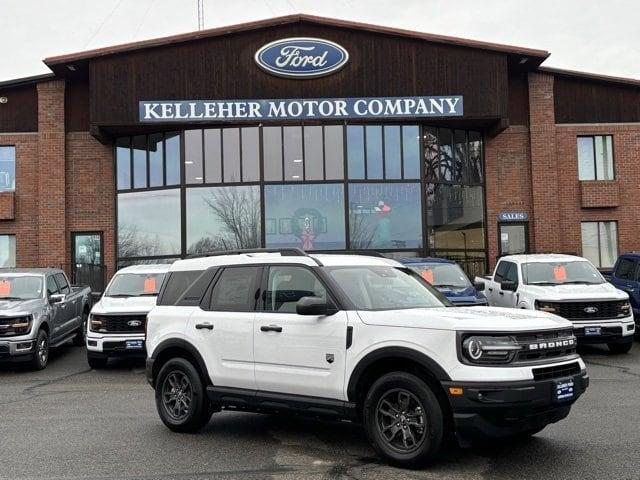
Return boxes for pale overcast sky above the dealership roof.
[0,0,640,81]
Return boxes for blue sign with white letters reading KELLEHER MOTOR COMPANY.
[138,95,464,123]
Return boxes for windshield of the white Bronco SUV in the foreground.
[327,266,448,310]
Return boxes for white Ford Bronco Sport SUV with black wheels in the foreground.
[147,248,589,467]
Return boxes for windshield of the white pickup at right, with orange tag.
[522,261,604,285]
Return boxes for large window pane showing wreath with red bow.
[264,184,345,250]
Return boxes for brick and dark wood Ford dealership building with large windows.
[0,15,640,289]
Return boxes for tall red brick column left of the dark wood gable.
[37,80,69,267]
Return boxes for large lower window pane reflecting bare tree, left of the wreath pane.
[186,185,260,254]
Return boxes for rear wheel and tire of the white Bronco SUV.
[155,357,213,433]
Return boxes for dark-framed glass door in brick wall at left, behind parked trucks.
[71,232,105,292]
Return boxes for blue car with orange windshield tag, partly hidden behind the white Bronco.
[399,257,488,307]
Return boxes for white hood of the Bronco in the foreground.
[358,307,573,332]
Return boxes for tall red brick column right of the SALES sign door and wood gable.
[529,73,561,252]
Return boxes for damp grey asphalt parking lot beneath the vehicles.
[0,342,640,480]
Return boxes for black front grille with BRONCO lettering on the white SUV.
[515,330,577,363]
